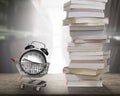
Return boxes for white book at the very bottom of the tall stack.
[67,80,103,87]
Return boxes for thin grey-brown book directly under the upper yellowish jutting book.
[70,26,105,31]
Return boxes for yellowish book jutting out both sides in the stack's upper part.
[63,17,108,25]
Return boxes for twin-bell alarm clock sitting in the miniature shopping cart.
[19,41,49,76]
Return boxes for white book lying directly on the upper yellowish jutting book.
[67,12,104,18]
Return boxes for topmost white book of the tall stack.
[64,0,105,8]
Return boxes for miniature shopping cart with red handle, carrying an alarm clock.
[10,41,49,91]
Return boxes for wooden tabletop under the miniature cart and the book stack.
[0,74,120,96]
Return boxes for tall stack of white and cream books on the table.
[63,0,110,87]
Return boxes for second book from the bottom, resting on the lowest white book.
[65,74,102,81]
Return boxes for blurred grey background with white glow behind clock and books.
[0,0,120,73]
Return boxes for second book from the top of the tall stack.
[64,4,105,10]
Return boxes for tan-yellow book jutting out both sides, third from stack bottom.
[63,65,109,76]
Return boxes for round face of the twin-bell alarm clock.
[20,50,46,75]
